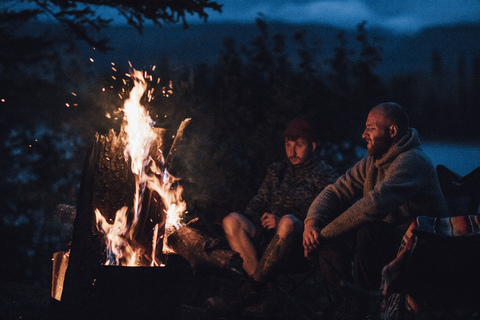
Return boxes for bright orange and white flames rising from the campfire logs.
[95,69,190,266]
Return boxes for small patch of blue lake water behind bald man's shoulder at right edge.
[422,141,480,176]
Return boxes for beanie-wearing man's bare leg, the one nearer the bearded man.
[252,215,303,283]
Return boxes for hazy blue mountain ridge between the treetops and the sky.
[86,23,480,78]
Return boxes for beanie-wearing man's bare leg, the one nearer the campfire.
[223,212,258,276]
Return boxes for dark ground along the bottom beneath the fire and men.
[0,258,480,320]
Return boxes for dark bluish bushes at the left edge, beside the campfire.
[0,77,83,282]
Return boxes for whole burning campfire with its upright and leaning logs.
[52,69,242,313]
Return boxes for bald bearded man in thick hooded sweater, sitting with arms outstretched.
[303,102,448,319]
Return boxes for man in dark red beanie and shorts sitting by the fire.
[207,118,337,313]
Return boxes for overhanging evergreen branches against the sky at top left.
[0,0,222,50]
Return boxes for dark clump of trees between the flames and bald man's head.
[161,19,387,218]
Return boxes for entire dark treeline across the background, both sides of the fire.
[0,19,480,285]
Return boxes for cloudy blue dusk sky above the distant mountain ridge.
[200,0,480,32]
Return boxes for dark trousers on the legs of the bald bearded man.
[318,222,402,319]
